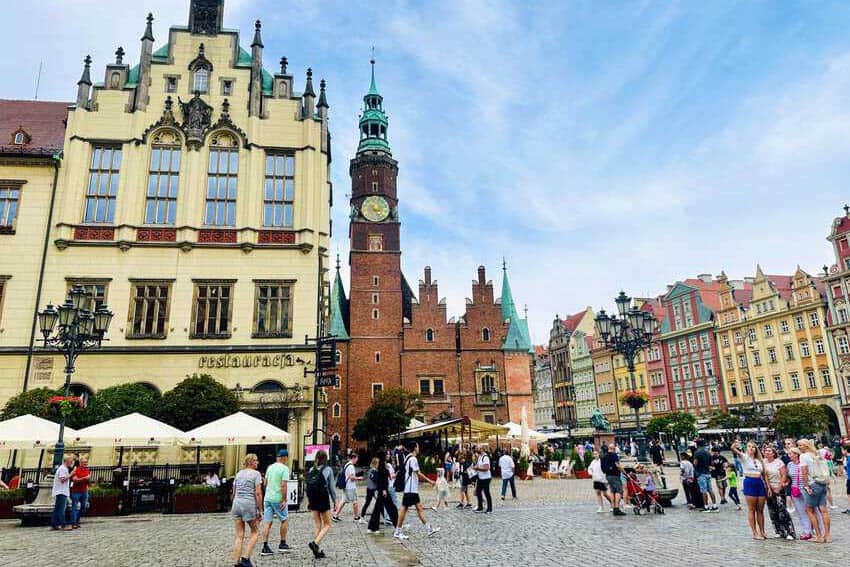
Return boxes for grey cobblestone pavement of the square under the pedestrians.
[0,474,850,567]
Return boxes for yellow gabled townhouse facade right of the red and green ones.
[716,267,841,428]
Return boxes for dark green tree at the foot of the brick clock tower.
[352,387,422,449]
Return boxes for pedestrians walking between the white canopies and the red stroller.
[231,442,517,567]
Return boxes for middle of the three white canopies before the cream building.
[69,413,185,447]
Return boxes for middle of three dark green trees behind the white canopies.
[72,383,162,428]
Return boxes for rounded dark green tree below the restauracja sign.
[158,374,239,431]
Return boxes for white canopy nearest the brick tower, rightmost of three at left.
[186,411,291,447]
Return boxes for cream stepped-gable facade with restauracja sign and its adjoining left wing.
[0,1,332,470]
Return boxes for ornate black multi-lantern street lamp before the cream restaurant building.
[38,285,112,470]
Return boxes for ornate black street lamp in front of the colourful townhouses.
[595,291,658,462]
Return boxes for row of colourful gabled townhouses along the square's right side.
[535,206,850,436]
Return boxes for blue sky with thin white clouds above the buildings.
[0,0,850,342]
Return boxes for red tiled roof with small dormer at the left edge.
[0,99,70,155]
